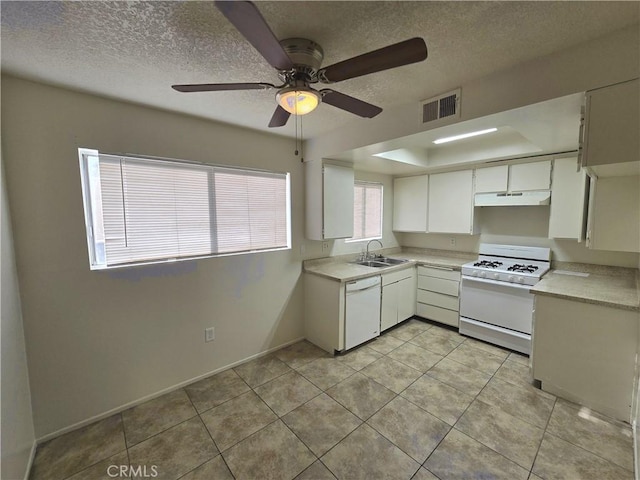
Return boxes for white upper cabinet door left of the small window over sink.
[322,164,354,239]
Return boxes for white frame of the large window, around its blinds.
[78,148,292,270]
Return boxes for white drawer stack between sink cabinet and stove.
[416,266,460,327]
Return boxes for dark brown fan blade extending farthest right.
[318,37,427,83]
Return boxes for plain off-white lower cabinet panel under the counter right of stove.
[532,295,638,422]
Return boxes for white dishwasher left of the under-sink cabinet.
[344,275,382,350]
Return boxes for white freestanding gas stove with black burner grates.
[460,244,551,355]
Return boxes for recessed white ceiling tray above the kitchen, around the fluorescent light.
[332,93,584,176]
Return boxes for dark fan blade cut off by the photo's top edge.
[215,0,293,70]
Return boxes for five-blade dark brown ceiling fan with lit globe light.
[172,0,427,127]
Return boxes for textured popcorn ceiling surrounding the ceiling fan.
[0,1,640,138]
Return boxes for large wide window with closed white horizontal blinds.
[79,149,291,269]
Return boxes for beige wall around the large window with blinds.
[2,77,303,438]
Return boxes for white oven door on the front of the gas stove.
[460,276,533,334]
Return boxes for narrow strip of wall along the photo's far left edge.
[0,148,35,479]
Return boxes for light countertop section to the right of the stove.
[531,264,640,312]
